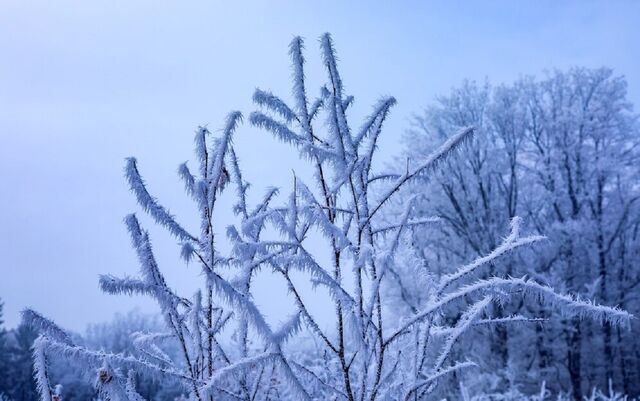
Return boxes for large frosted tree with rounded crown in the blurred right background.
[405,69,640,399]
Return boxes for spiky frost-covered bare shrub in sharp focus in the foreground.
[24,34,630,401]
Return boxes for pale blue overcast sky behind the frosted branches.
[0,0,640,330]
